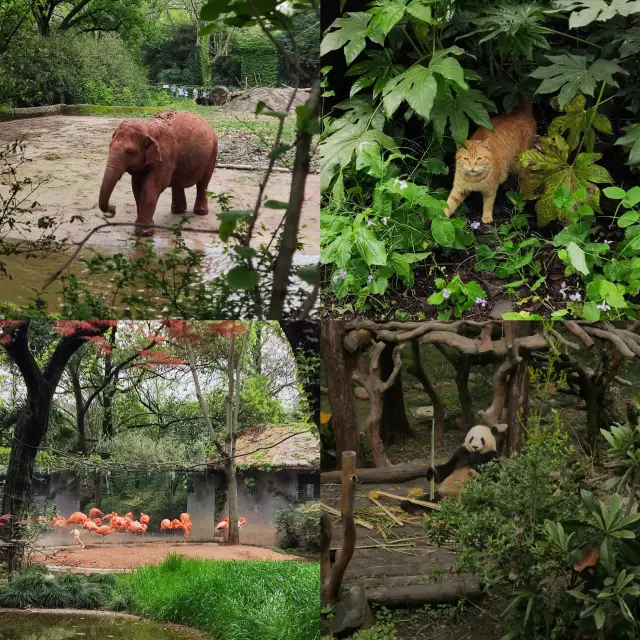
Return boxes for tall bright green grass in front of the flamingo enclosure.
[116,556,320,640]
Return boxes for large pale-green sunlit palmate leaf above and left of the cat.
[382,47,469,120]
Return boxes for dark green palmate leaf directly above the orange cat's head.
[431,89,497,144]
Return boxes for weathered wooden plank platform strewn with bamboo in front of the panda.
[321,478,479,606]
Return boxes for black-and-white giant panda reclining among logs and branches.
[400,424,507,513]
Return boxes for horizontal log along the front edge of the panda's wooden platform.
[367,580,482,607]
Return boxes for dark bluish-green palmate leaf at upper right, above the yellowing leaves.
[529,53,627,107]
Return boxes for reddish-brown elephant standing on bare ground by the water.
[100,111,218,236]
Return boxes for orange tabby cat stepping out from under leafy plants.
[444,102,536,224]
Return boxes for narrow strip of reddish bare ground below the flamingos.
[34,542,300,569]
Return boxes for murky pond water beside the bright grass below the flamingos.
[0,612,210,640]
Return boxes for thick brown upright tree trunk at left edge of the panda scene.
[321,320,364,468]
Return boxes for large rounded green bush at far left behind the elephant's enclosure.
[0,34,149,107]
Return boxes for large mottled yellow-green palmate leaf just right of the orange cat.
[518,136,613,227]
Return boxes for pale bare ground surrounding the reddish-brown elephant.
[0,113,320,254]
